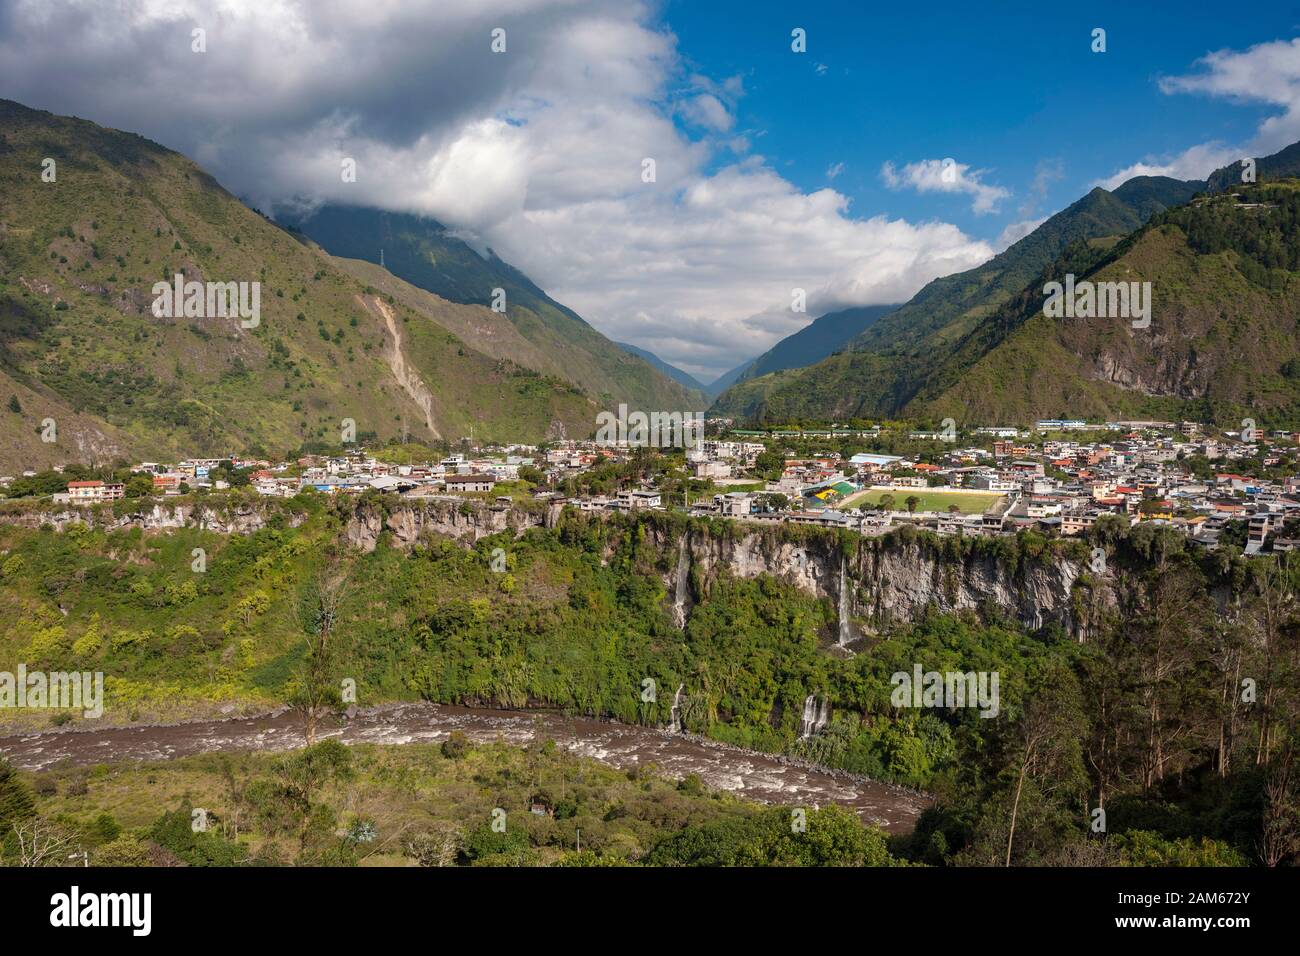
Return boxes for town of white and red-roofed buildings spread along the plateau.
[0,419,1300,554]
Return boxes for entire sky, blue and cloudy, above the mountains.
[0,0,1300,381]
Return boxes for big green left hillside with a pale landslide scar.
[0,100,689,473]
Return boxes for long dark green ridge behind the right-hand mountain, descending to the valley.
[712,177,1205,421]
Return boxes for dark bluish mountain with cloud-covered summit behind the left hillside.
[281,206,703,411]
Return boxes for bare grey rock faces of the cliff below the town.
[0,498,1115,645]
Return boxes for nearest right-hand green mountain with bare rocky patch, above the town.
[905,179,1300,427]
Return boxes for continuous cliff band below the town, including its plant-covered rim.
[0,494,1122,646]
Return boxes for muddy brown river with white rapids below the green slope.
[0,704,928,832]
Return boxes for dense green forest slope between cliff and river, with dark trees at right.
[0,494,1300,865]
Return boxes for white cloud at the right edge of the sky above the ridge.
[1100,38,1300,189]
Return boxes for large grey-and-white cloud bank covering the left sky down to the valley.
[0,0,987,376]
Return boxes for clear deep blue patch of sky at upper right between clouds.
[662,0,1300,247]
